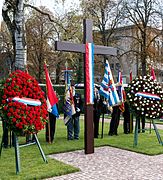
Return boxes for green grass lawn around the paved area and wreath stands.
[0,114,163,180]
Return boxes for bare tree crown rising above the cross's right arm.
[81,0,121,46]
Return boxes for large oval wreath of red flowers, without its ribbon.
[2,70,47,135]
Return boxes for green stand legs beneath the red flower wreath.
[0,126,48,174]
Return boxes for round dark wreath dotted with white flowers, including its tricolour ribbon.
[127,76,163,119]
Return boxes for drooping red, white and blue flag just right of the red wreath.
[44,65,59,117]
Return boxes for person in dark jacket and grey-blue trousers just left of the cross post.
[67,87,83,140]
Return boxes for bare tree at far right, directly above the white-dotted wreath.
[123,0,161,76]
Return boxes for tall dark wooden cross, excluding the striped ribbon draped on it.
[55,19,117,154]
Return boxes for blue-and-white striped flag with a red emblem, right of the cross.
[99,61,120,106]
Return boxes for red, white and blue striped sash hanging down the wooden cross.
[85,43,94,104]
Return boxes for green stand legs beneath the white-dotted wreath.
[134,119,163,147]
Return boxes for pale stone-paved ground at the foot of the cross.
[48,121,163,180]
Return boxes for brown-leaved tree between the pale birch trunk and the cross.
[26,7,57,83]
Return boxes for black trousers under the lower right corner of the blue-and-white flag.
[109,106,121,135]
